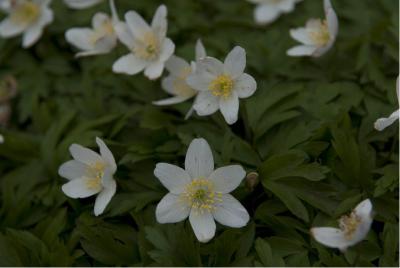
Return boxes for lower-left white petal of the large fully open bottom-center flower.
[156,193,190,223]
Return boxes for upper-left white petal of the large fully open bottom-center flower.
[154,163,191,194]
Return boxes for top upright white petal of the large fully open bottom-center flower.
[185,138,214,179]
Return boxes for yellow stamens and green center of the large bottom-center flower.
[181,179,222,214]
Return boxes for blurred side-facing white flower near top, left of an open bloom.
[65,0,118,57]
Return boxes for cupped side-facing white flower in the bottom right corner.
[311,199,372,251]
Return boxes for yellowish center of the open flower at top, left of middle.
[133,32,160,60]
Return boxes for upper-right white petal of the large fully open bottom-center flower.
[209,165,246,194]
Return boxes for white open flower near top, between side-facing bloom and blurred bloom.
[113,5,175,79]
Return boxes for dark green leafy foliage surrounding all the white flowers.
[0,0,399,266]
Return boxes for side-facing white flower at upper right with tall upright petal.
[287,0,339,57]
